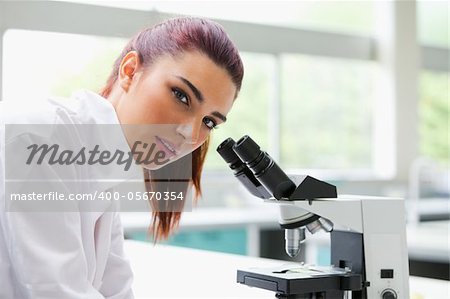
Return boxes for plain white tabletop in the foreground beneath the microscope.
[125,240,450,299]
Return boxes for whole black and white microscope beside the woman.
[217,136,409,299]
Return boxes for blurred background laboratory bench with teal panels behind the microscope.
[121,204,450,280]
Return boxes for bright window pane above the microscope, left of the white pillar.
[281,55,374,170]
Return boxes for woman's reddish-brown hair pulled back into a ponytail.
[100,17,244,241]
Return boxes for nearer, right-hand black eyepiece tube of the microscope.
[233,135,295,199]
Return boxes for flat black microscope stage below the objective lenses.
[237,264,362,295]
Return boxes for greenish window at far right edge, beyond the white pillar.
[417,0,450,167]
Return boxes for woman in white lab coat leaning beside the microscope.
[0,18,243,299]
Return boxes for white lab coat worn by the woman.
[0,90,134,299]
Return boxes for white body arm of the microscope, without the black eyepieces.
[272,195,409,299]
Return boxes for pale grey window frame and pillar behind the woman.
[0,1,450,180]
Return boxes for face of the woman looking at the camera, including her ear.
[108,51,236,169]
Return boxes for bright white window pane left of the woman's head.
[3,30,125,101]
